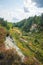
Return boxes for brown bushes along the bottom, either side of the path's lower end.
[0,49,39,65]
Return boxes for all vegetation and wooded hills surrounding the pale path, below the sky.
[0,14,43,65]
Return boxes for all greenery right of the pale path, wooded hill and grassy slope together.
[10,14,43,64]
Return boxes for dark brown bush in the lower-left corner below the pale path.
[0,49,21,65]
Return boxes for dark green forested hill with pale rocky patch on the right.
[13,14,43,32]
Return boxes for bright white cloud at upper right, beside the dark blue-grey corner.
[24,0,43,15]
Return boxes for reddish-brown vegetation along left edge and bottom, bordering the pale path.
[0,27,39,65]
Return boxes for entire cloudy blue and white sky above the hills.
[0,0,43,22]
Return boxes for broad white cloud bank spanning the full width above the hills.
[0,0,43,21]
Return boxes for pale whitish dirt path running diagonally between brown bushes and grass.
[5,36,25,60]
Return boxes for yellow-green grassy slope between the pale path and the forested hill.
[10,28,43,64]
